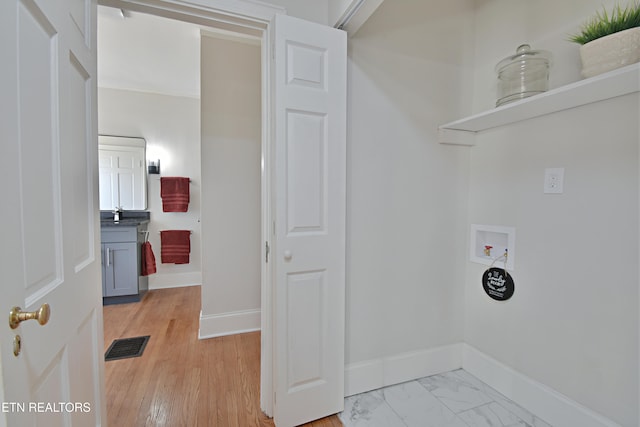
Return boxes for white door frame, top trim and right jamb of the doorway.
[98,0,278,417]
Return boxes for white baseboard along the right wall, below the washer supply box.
[462,344,620,427]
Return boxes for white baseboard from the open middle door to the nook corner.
[345,344,463,396]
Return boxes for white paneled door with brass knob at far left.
[0,0,106,426]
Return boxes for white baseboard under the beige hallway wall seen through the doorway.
[198,308,261,339]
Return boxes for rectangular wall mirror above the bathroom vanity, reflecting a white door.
[98,135,147,211]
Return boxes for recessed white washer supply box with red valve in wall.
[469,224,516,271]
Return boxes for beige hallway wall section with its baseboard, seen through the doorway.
[200,37,262,337]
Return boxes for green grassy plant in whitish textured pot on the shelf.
[569,0,640,78]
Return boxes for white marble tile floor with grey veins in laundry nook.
[339,369,552,427]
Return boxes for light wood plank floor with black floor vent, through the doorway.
[104,286,342,427]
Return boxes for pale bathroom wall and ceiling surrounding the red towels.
[98,6,202,298]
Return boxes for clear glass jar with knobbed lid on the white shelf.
[496,44,551,107]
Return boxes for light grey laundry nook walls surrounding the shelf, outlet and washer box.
[347,0,640,427]
